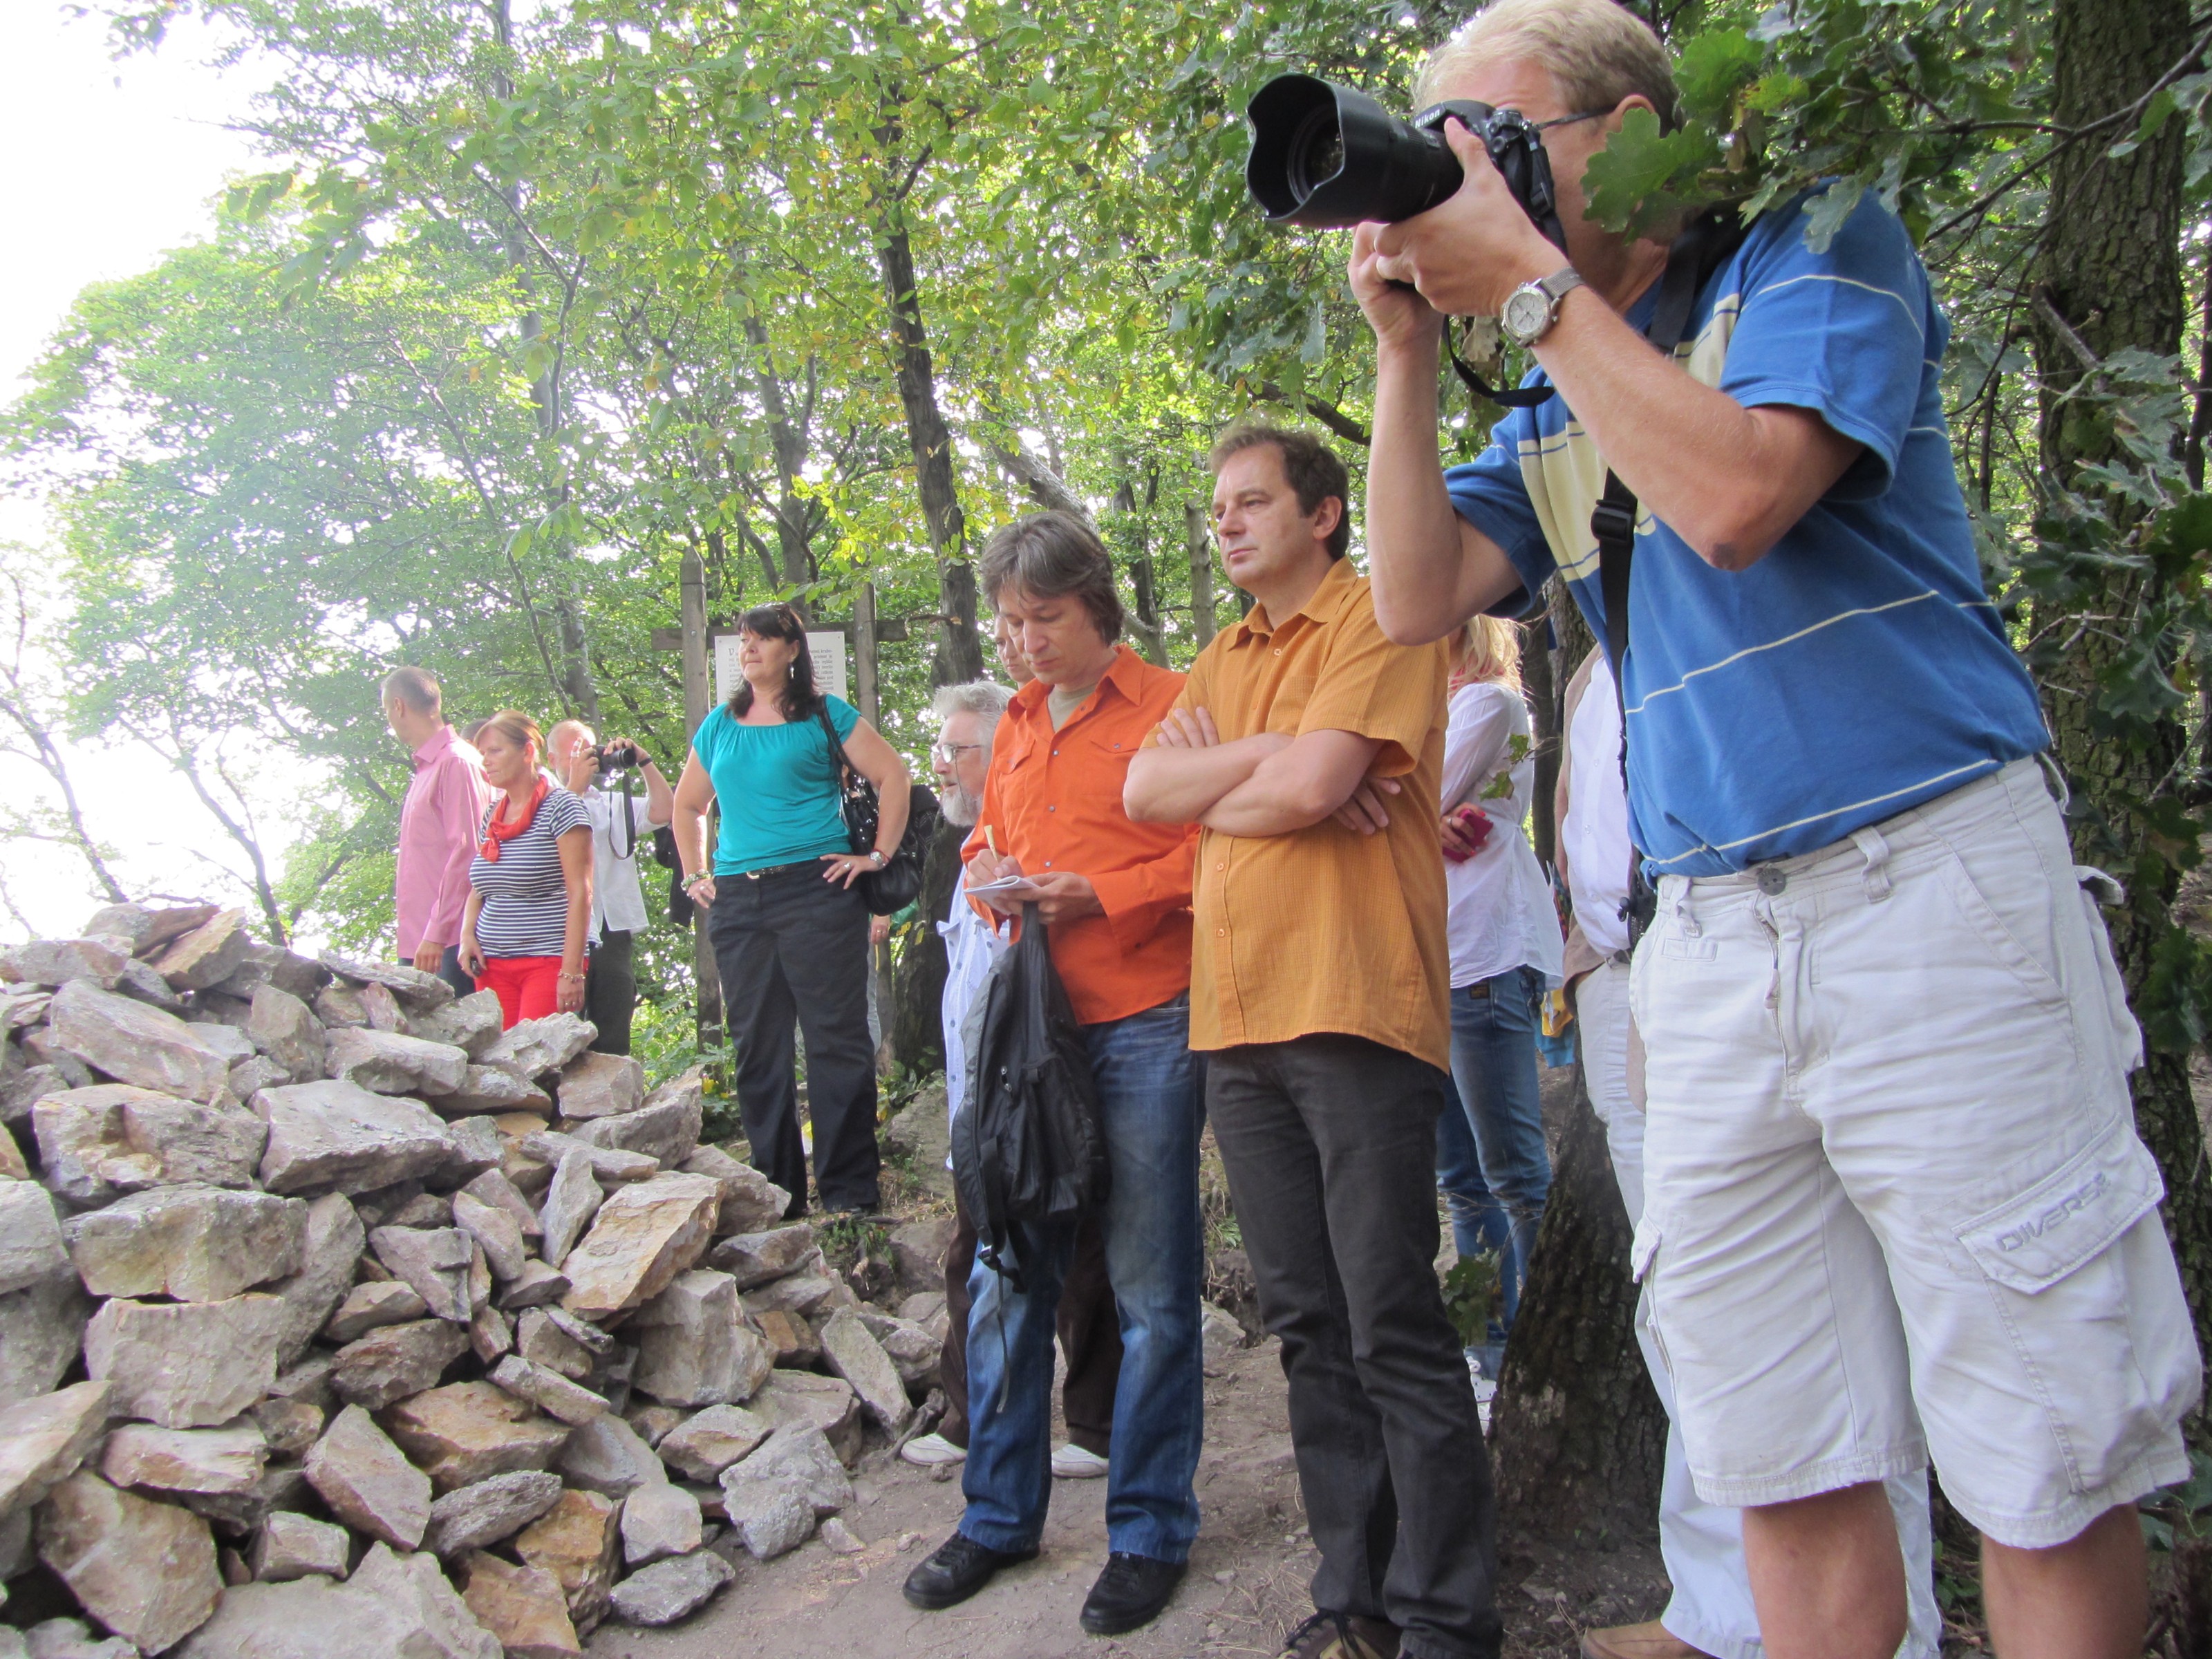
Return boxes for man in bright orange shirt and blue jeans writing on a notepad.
[905,513,1203,1635]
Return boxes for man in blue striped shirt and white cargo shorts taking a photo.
[1318,0,2201,1659]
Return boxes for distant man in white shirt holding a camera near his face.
[546,721,677,1055]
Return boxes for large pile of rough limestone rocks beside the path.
[0,905,942,1659]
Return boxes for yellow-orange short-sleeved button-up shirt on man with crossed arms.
[1177,560,1451,1069]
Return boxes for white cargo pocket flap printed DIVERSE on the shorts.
[1955,1121,2166,1296]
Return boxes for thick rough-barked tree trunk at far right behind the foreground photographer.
[2031,0,2212,1398]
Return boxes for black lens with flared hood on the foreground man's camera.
[1246,75,1460,230]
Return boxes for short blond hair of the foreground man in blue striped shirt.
[1414,0,1677,133]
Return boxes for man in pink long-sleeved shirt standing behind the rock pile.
[383,668,491,995]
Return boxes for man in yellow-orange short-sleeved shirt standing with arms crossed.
[1126,427,1500,1659]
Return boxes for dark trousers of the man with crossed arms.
[1206,1035,1500,1659]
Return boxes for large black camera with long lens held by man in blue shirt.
[1246,75,1566,250]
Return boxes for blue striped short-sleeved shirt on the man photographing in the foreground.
[1447,195,2046,876]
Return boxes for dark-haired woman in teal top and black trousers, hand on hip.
[675,604,909,1219]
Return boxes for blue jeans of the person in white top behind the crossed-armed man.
[1451,966,1550,1331]
